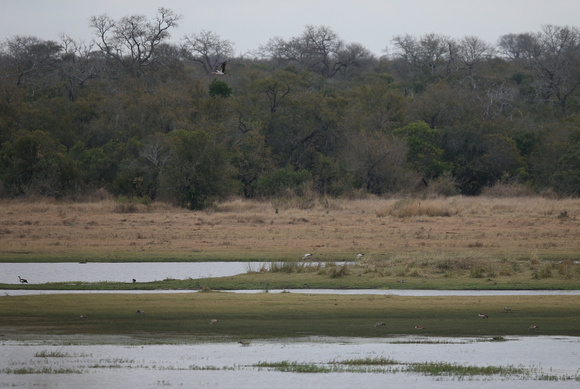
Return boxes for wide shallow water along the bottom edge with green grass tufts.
[0,336,580,388]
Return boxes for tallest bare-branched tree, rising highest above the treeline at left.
[90,8,181,75]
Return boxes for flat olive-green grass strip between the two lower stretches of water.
[0,292,580,342]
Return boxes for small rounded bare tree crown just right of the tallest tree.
[183,30,235,74]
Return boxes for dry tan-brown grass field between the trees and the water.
[0,197,580,261]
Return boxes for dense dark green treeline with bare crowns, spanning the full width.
[0,8,580,209]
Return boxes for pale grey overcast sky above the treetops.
[0,0,580,56]
